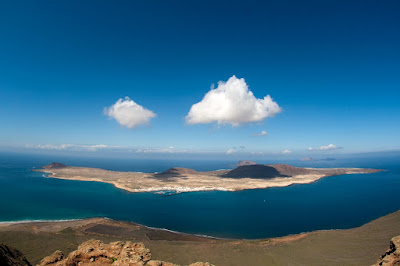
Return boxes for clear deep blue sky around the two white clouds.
[0,0,400,156]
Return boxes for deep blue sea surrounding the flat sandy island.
[0,153,400,239]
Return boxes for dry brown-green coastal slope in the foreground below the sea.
[0,211,400,266]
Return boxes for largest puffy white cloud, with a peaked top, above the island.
[186,76,281,126]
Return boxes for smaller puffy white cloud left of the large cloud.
[104,97,156,128]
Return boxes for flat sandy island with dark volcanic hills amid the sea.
[34,161,382,194]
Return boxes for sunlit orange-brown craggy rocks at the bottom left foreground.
[39,239,211,266]
